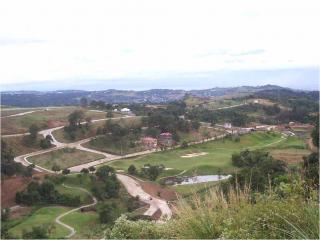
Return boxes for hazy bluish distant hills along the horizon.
[1,85,310,107]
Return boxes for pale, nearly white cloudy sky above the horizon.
[0,0,320,90]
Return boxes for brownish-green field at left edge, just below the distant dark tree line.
[1,107,106,134]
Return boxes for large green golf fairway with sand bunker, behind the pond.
[109,133,303,175]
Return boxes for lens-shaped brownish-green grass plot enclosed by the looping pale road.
[28,148,104,169]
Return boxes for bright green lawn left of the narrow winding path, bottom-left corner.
[9,206,69,238]
